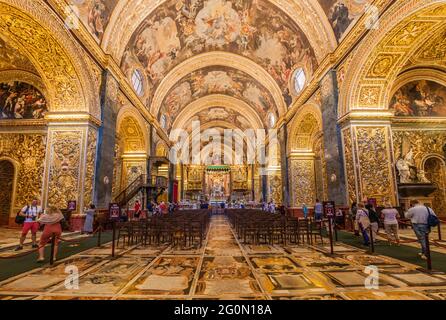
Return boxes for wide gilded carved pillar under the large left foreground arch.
[43,113,99,214]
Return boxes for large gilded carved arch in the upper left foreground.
[0,0,100,119]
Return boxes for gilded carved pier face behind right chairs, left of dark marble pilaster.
[289,159,316,207]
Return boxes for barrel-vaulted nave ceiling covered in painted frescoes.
[71,0,365,136]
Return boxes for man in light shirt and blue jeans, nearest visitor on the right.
[405,200,435,260]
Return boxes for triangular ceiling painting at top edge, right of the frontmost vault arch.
[319,0,365,41]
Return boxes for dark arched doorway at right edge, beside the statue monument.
[424,157,446,215]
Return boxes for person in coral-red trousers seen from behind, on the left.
[37,207,64,262]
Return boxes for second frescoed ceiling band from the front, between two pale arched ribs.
[158,66,277,129]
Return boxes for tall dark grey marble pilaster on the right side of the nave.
[320,70,346,205]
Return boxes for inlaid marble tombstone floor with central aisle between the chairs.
[0,216,446,300]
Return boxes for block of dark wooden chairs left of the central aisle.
[116,210,209,247]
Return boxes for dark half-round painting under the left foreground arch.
[0,81,48,120]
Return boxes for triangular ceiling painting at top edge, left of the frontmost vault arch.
[71,0,119,42]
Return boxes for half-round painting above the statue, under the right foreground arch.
[390,80,446,117]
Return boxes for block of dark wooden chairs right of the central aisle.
[227,209,324,245]
